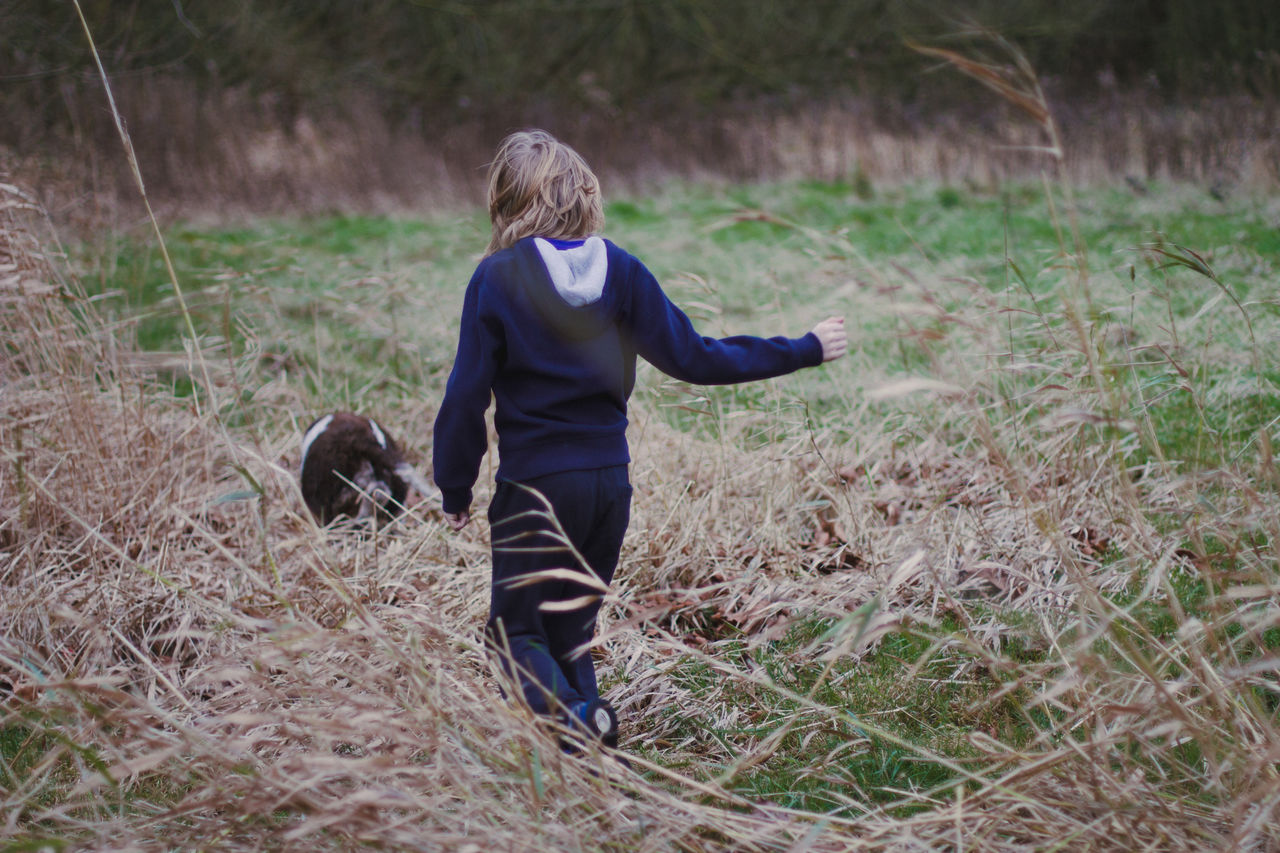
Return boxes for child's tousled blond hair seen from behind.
[485,131,604,255]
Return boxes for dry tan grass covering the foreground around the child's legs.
[10,161,1280,850]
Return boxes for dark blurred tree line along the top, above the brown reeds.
[10,0,1280,126]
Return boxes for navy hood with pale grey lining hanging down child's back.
[525,237,614,341]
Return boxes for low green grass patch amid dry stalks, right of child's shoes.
[655,620,1043,817]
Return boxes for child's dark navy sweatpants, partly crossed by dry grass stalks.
[486,465,631,713]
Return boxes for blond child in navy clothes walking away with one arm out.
[434,131,847,747]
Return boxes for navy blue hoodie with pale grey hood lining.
[433,237,822,514]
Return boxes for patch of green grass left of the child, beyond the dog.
[78,207,484,407]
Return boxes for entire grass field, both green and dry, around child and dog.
[0,174,1280,850]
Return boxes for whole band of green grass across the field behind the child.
[78,174,1280,469]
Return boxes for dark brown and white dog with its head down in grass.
[302,411,430,524]
